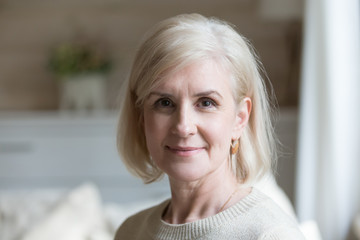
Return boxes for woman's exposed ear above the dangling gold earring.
[232,97,252,140]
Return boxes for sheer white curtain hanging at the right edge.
[296,0,360,240]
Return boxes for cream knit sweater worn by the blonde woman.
[115,188,305,240]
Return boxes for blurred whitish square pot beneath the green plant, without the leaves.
[60,73,106,111]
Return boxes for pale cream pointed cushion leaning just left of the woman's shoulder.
[22,184,112,240]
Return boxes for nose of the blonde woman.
[172,106,197,138]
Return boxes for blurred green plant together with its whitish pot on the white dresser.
[49,43,111,110]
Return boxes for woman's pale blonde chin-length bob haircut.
[117,14,276,184]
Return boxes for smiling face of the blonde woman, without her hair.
[144,60,248,181]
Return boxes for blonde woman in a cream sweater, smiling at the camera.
[115,14,303,239]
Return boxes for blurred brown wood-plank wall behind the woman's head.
[0,0,303,110]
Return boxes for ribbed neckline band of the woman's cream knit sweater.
[148,188,266,240]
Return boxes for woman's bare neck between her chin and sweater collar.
[163,162,247,224]
